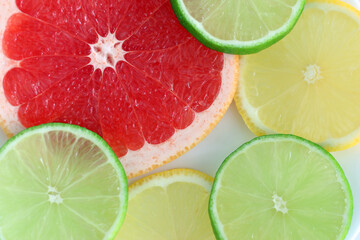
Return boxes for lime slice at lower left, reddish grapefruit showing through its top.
[0,123,127,240]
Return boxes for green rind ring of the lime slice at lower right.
[209,134,353,240]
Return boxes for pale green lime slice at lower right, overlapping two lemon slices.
[209,135,353,240]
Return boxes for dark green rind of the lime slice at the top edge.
[170,0,306,55]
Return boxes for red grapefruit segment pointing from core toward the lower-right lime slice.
[116,63,194,144]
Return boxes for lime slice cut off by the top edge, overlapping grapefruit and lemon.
[170,0,305,54]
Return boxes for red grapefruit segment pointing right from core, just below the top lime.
[126,39,224,112]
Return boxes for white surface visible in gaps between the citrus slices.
[0,0,360,240]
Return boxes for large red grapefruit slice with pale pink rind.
[0,0,238,177]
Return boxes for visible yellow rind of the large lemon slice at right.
[234,0,360,152]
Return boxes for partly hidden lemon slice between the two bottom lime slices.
[115,169,215,240]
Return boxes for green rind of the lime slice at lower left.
[0,123,128,240]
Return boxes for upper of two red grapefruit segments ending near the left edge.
[2,13,90,60]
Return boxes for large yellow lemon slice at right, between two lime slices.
[235,0,360,151]
